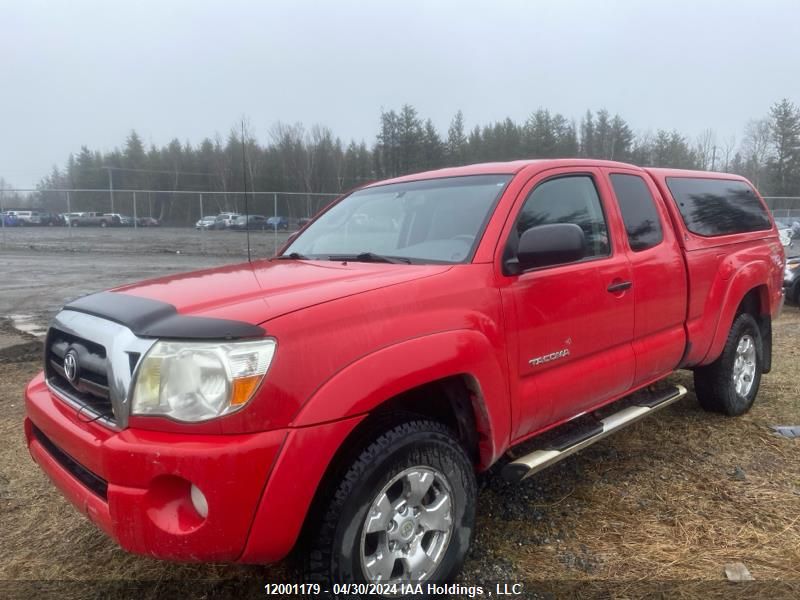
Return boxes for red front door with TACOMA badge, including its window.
[501,168,635,437]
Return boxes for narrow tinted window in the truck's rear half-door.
[611,173,664,252]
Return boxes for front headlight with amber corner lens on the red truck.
[131,339,276,422]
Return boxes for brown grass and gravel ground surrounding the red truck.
[0,237,800,599]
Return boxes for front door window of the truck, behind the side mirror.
[517,175,610,258]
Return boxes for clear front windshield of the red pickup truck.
[283,175,511,263]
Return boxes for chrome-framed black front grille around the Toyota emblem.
[44,309,155,429]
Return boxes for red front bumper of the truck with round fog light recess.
[25,374,288,562]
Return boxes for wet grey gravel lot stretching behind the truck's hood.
[0,227,288,338]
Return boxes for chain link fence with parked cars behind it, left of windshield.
[0,189,338,256]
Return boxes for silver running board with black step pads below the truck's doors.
[502,385,686,482]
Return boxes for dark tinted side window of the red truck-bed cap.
[667,177,772,236]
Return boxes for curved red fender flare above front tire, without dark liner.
[291,329,511,466]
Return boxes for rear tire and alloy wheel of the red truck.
[694,313,764,417]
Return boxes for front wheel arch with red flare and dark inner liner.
[292,330,511,469]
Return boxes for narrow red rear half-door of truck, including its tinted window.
[604,168,687,385]
